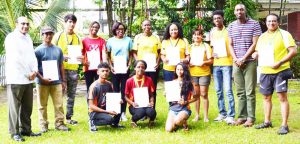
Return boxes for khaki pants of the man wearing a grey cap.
[37,84,64,128]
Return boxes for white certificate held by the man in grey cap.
[42,60,59,80]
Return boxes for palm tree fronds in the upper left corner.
[0,0,69,54]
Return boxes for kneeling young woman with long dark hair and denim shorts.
[166,63,199,132]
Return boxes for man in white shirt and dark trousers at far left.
[4,17,41,141]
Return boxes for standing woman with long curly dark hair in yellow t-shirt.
[161,22,190,81]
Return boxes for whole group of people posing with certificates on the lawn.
[5,4,297,141]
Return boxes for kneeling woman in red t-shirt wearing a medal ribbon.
[125,60,156,128]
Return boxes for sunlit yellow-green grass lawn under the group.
[0,82,300,144]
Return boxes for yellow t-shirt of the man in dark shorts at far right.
[255,29,296,74]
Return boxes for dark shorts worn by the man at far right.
[259,72,288,95]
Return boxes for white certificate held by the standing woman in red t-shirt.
[86,49,100,70]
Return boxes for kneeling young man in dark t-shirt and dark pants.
[88,63,125,132]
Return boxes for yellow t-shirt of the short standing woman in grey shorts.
[190,42,212,77]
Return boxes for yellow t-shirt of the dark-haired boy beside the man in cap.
[52,32,82,70]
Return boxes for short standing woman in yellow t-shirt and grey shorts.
[190,29,213,122]
